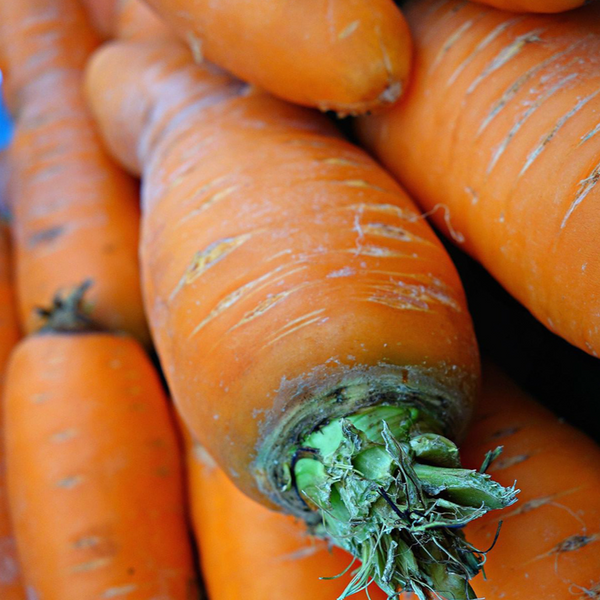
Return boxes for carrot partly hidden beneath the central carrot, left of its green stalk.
[187,444,387,600]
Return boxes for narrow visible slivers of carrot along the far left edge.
[0,220,25,600]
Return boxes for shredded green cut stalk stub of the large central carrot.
[288,405,518,600]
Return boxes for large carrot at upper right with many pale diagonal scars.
[359,0,600,355]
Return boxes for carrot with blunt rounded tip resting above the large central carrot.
[141,0,412,114]
